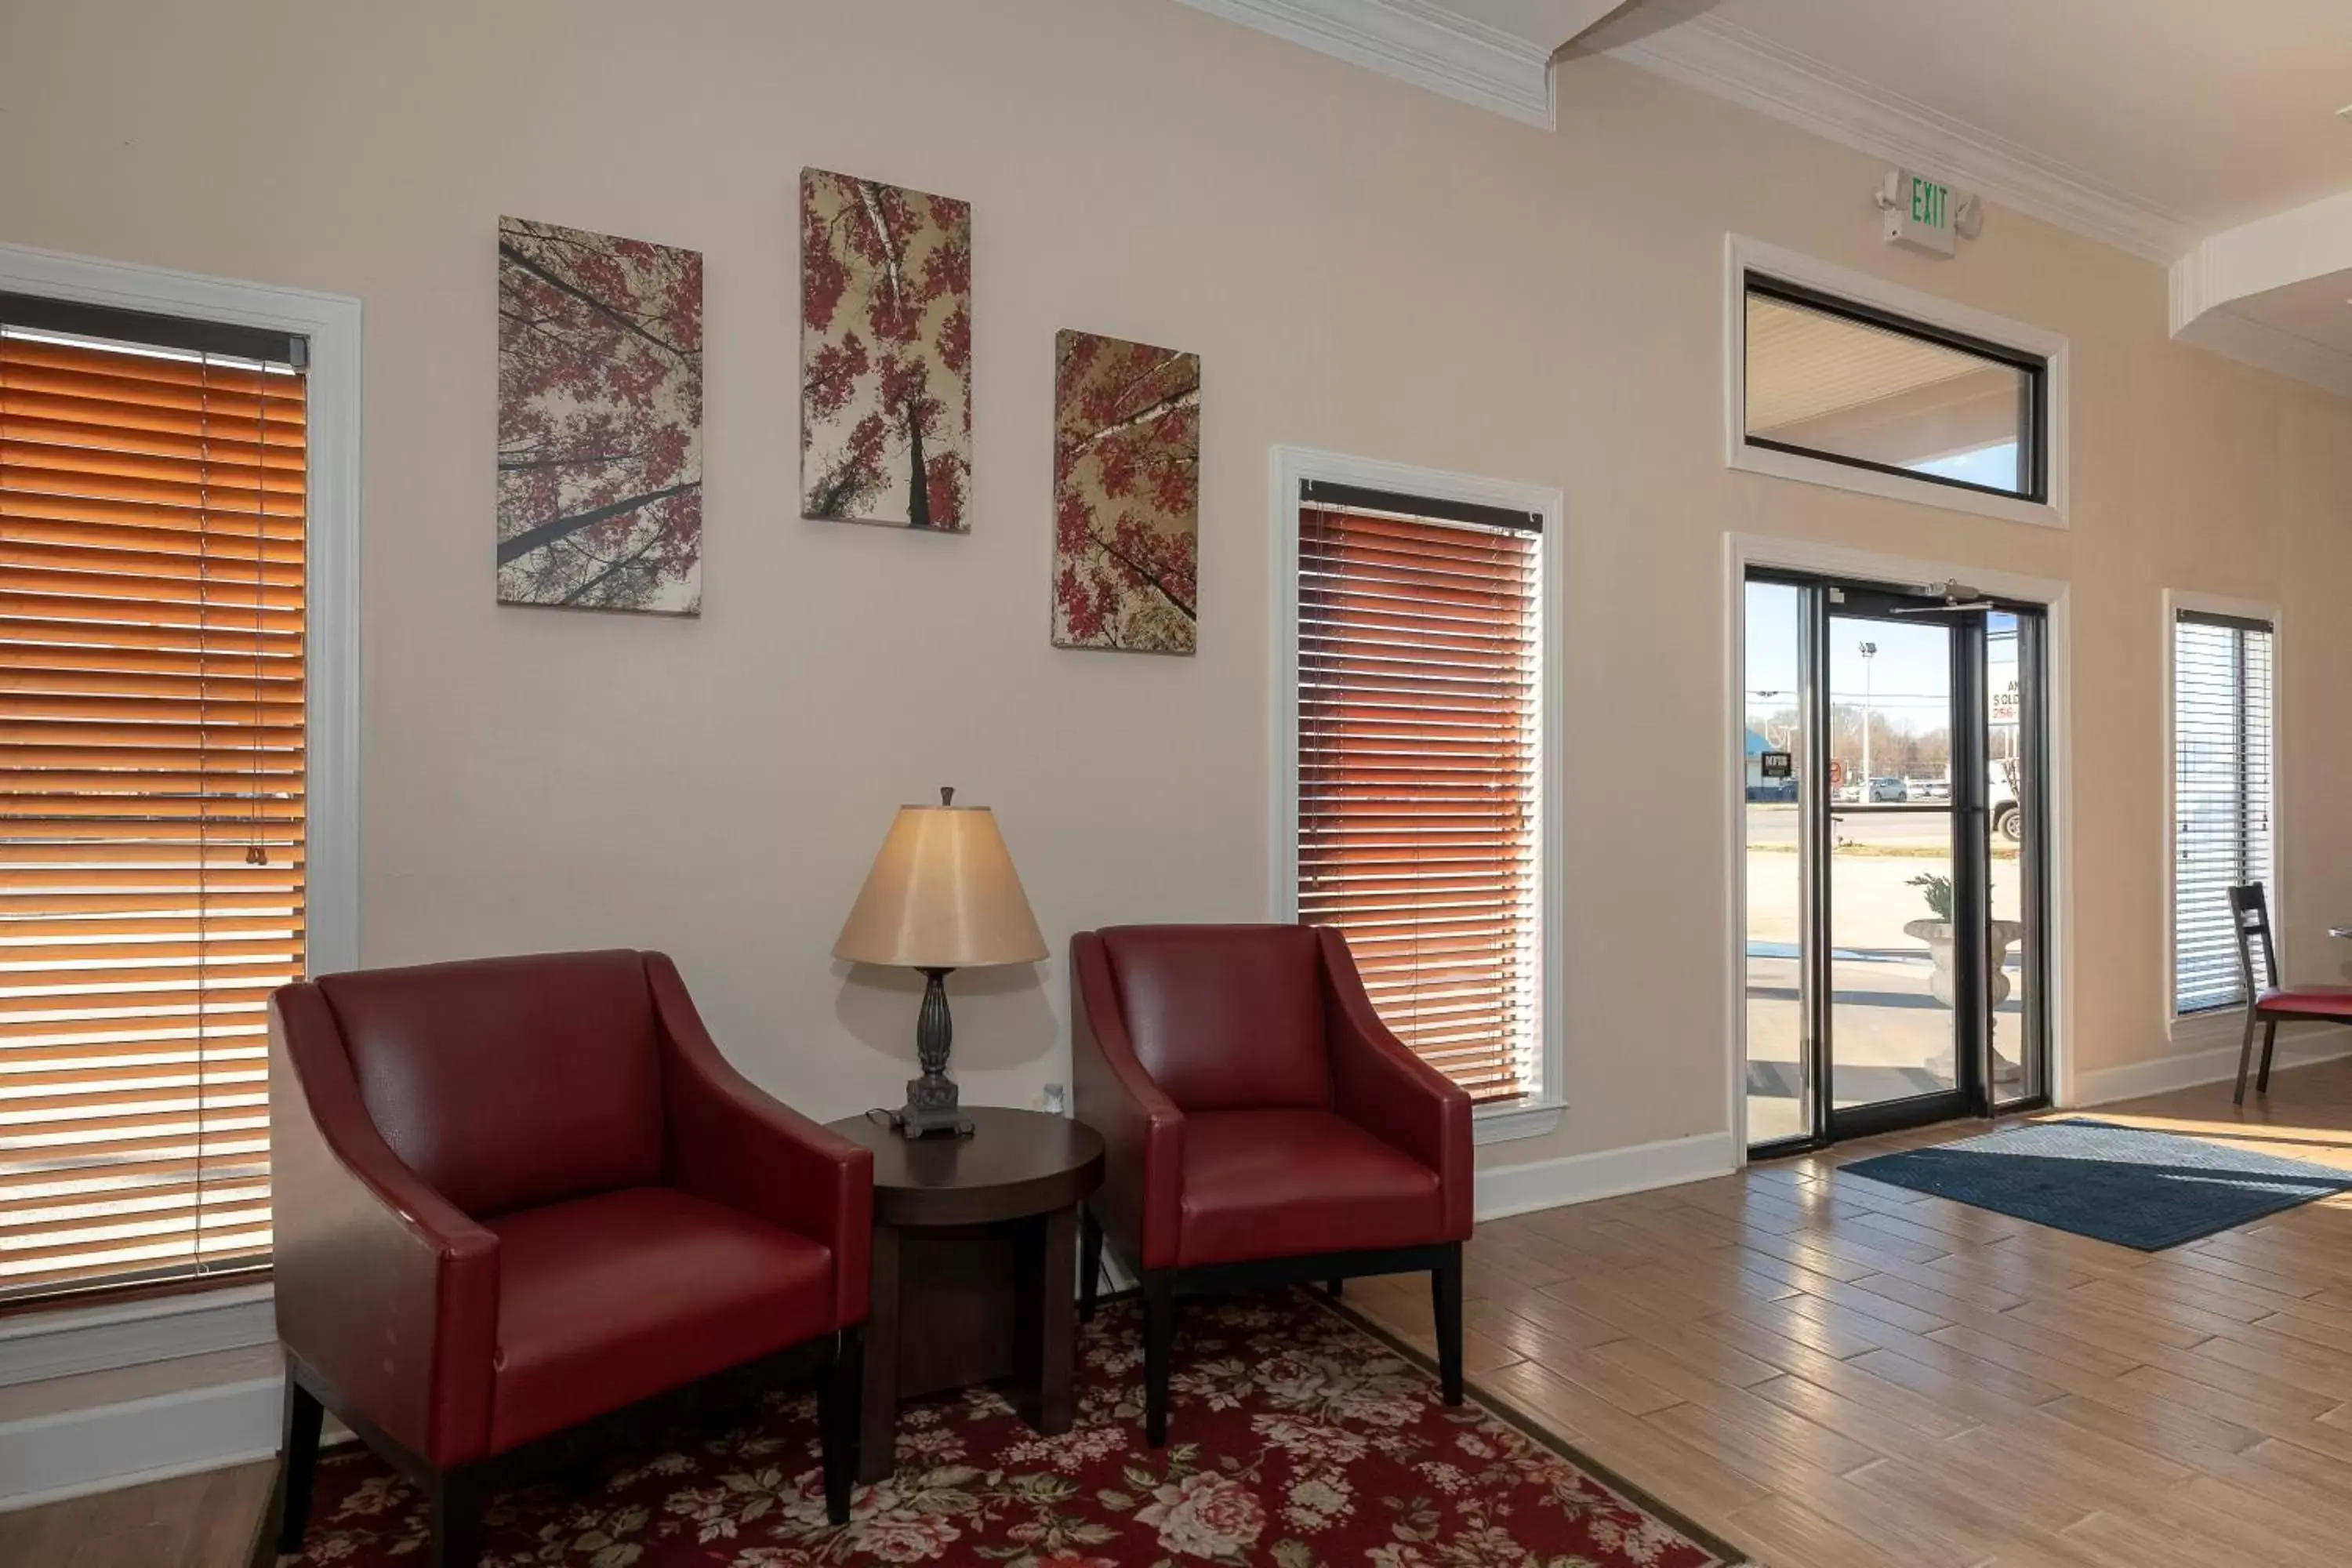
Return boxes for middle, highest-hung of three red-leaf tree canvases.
[800,169,971,534]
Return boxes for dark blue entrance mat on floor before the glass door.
[1846,1121,2352,1253]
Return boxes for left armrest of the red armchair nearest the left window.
[270,985,499,1467]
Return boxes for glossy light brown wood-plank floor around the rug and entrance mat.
[13,1060,2352,1568]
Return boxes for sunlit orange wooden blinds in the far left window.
[0,315,306,1298]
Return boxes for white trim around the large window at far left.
[0,245,360,1370]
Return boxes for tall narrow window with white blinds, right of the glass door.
[2173,612,2272,1013]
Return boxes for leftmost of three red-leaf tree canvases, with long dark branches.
[499,219,703,616]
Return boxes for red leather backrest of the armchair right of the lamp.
[1101,926,1331,1112]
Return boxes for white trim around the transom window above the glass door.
[1724,235,2067,529]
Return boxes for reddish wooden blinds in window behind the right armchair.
[1296,506,1543,1100]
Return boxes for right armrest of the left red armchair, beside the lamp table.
[644,952,875,1328]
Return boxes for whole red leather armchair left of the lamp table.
[270,952,873,1568]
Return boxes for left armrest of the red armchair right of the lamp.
[1070,931,1183,1269]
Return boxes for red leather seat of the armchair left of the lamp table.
[489,1187,833,1453]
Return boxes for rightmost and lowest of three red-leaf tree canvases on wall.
[1054,332,1200,654]
